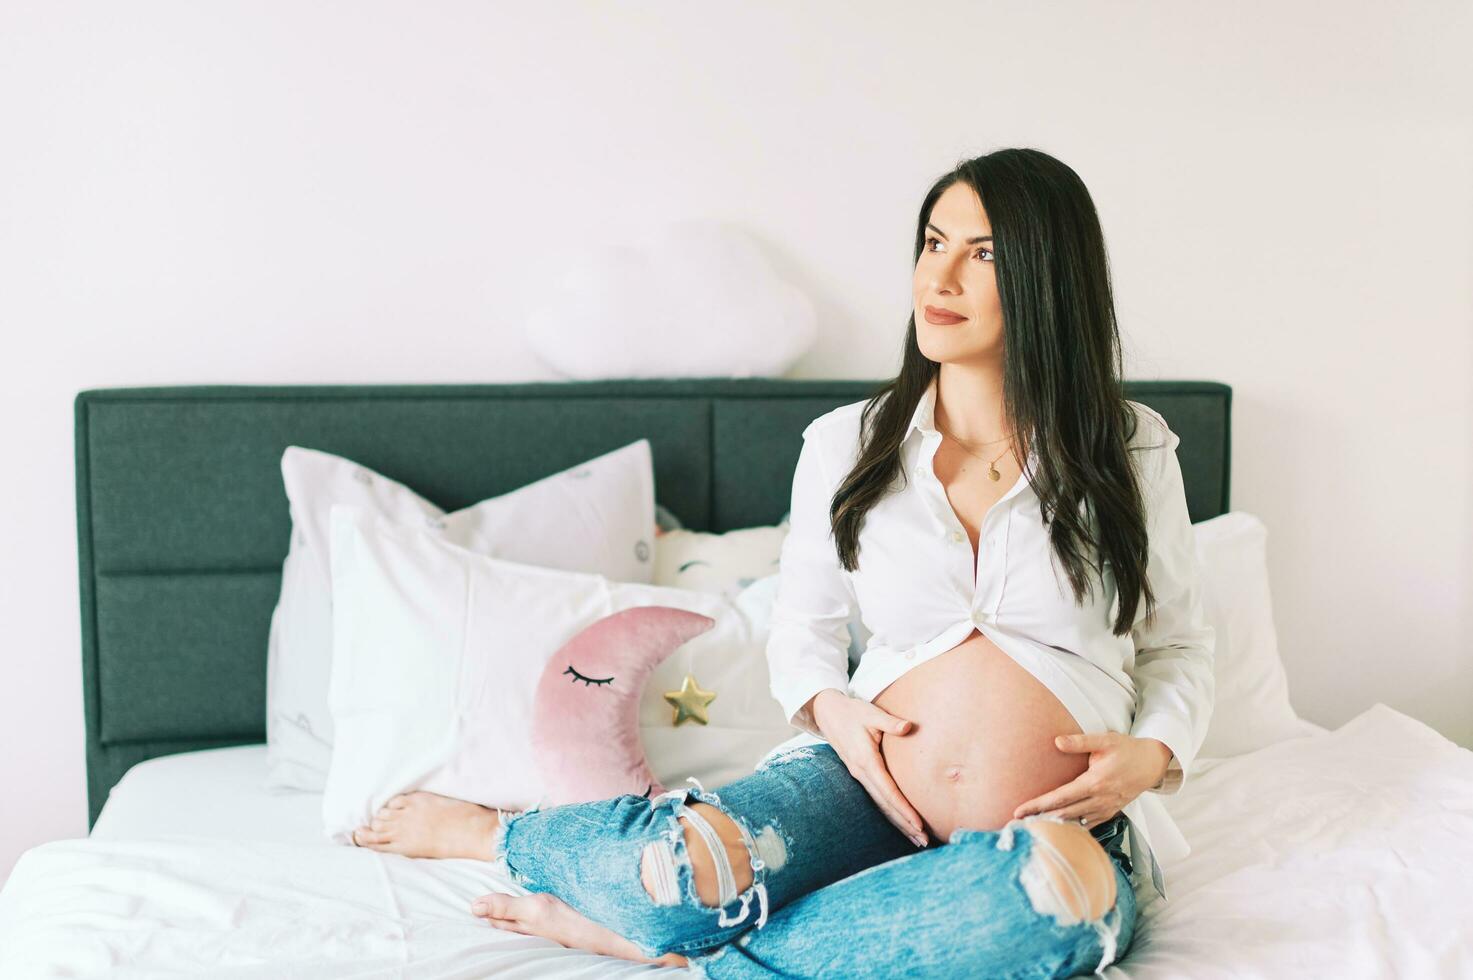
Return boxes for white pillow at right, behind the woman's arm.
[1193,511,1305,757]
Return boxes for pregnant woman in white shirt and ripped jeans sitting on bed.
[355,149,1214,977]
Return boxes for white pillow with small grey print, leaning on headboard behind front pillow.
[267,439,655,790]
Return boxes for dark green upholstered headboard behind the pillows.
[75,379,1231,824]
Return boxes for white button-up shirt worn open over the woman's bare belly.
[767,380,1215,897]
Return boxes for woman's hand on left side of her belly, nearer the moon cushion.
[810,687,927,847]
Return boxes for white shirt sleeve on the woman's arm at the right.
[1130,420,1217,794]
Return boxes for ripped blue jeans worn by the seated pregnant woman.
[493,744,1136,979]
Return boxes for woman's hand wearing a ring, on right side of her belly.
[1013,731,1171,827]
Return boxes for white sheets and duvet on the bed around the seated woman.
[0,704,1473,980]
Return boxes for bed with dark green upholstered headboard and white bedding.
[0,379,1473,977]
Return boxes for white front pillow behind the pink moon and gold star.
[323,505,792,843]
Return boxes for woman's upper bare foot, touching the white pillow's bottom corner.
[354,790,501,861]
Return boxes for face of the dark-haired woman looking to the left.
[912,181,1003,363]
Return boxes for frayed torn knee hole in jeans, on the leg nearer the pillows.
[639,780,788,927]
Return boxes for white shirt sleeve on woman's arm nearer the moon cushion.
[767,426,857,738]
